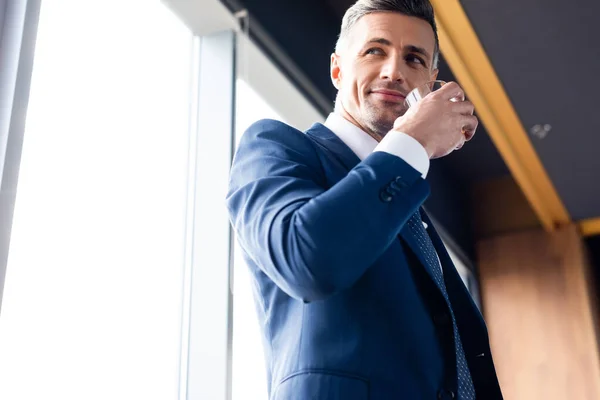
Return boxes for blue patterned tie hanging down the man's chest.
[408,211,475,400]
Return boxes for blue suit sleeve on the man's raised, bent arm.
[227,120,429,302]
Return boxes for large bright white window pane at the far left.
[0,0,192,400]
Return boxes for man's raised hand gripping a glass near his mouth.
[392,82,479,158]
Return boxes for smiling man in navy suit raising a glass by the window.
[227,0,502,400]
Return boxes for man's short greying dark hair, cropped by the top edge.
[335,0,440,68]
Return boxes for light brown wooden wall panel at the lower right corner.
[478,225,600,400]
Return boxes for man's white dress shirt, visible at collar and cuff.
[324,112,441,248]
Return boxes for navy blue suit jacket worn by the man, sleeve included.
[227,120,502,400]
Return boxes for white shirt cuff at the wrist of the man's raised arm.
[373,131,429,179]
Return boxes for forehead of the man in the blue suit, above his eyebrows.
[349,12,435,54]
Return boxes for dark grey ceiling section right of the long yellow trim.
[461,0,600,220]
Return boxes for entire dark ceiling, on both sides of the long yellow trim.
[222,0,600,262]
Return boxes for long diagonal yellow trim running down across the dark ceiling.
[431,0,570,231]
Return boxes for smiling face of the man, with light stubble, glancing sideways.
[331,12,438,137]
